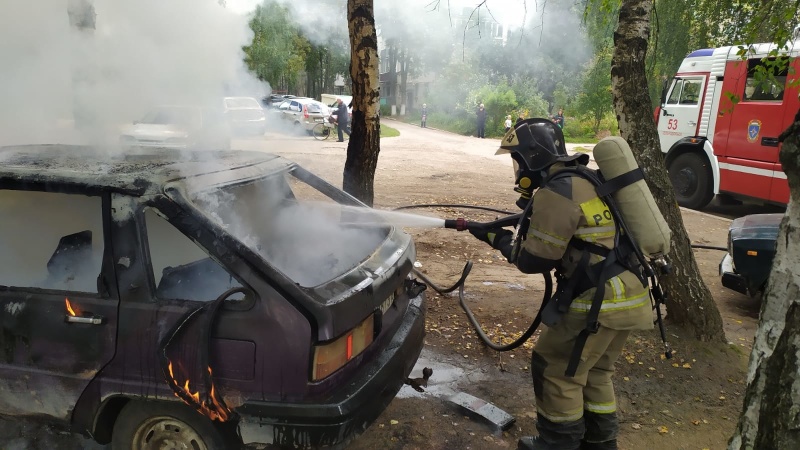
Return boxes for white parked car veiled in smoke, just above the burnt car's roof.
[119,105,231,150]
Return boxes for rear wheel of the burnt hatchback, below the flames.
[111,401,231,450]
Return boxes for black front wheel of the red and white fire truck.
[668,153,714,209]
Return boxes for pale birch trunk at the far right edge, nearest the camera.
[728,111,800,450]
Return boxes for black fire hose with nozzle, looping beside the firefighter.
[395,204,727,357]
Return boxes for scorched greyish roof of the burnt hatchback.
[0,144,293,195]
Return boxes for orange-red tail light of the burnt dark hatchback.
[311,315,375,381]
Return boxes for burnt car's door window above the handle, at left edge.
[0,189,104,293]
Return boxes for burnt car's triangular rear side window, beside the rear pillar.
[144,208,241,302]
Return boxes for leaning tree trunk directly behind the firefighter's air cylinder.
[611,0,725,342]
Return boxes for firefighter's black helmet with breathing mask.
[495,118,588,209]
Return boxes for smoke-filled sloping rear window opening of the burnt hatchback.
[184,170,390,287]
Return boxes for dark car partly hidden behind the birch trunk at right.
[719,214,783,296]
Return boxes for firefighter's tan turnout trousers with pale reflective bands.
[531,314,630,442]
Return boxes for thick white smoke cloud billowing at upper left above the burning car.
[0,0,269,145]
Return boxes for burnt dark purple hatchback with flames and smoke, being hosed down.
[0,145,425,450]
